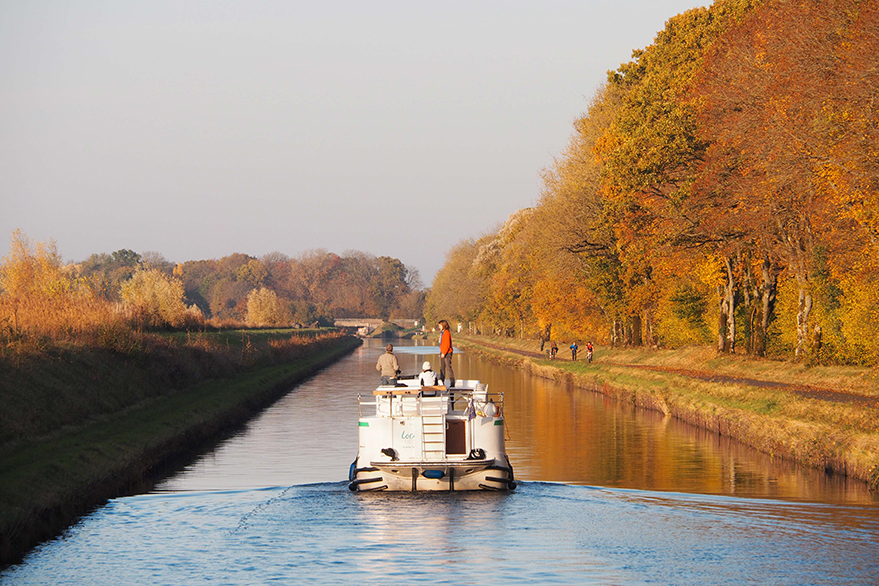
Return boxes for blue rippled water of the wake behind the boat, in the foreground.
[2,482,879,584]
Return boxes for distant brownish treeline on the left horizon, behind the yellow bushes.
[76,243,423,325]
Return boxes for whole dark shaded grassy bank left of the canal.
[0,332,360,564]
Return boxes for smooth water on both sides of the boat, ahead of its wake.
[158,340,879,503]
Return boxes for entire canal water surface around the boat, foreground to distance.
[0,341,879,585]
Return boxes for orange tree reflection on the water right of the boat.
[455,346,879,503]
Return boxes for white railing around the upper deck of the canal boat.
[357,387,504,419]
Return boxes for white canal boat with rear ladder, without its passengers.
[348,379,516,492]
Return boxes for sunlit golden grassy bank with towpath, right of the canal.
[455,335,879,490]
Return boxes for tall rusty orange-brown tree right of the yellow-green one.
[700,1,875,357]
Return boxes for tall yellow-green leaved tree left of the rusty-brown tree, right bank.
[595,0,752,351]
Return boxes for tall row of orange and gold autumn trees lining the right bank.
[427,0,879,364]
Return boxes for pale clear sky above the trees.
[0,0,705,284]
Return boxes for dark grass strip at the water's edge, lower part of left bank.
[0,337,360,566]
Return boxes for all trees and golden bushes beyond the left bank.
[0,231,424,338]
